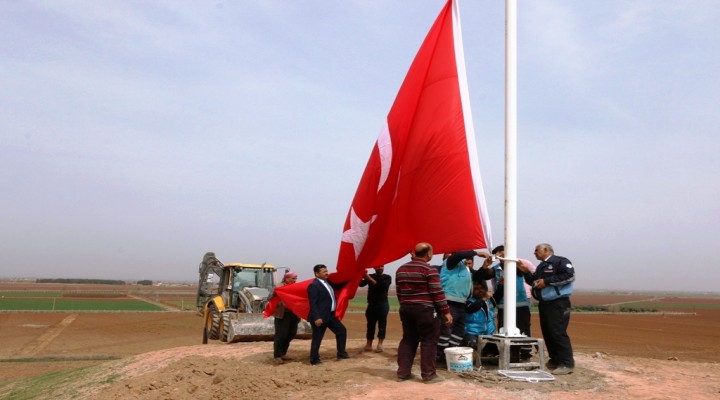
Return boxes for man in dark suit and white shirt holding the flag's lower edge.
[307,264,350,365]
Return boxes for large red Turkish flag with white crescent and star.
[264,0,490,319]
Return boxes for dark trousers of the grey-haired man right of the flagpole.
[538,297,575,368]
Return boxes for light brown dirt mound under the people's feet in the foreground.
[47,338,720,400]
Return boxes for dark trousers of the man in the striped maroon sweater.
[397,304,440,380]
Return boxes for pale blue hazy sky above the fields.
[0,0,720,291]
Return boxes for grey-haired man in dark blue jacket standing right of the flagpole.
[518,243,575,375]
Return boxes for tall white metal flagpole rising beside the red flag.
[500,0,522,337]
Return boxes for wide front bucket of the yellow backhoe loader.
[227,313,312,343]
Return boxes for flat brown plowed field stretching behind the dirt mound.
[0,285,720,399]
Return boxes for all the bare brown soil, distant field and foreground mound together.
[0,282,720,400]
